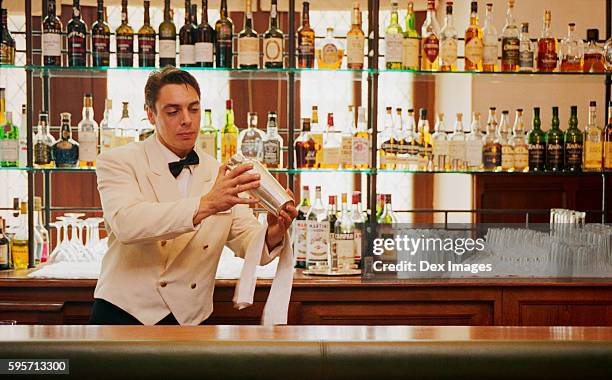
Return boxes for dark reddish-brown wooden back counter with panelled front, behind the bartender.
[0,270,612,326]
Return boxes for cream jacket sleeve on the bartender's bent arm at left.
[96,150,200,244]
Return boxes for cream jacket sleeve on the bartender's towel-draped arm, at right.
[227,205,287,265]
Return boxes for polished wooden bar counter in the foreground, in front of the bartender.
[0,325,612,380]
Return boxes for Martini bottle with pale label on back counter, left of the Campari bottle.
[306,186,336,270]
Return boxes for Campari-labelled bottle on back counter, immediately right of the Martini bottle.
[331,193,355,272]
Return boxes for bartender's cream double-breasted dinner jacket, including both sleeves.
[94,135,282,325]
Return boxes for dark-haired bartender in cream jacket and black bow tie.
[90,67,297,325]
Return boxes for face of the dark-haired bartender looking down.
[147,84,200,157]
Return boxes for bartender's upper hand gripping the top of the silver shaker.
[193,164,259,226]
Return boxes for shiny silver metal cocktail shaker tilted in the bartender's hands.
[227,153,294,216]
